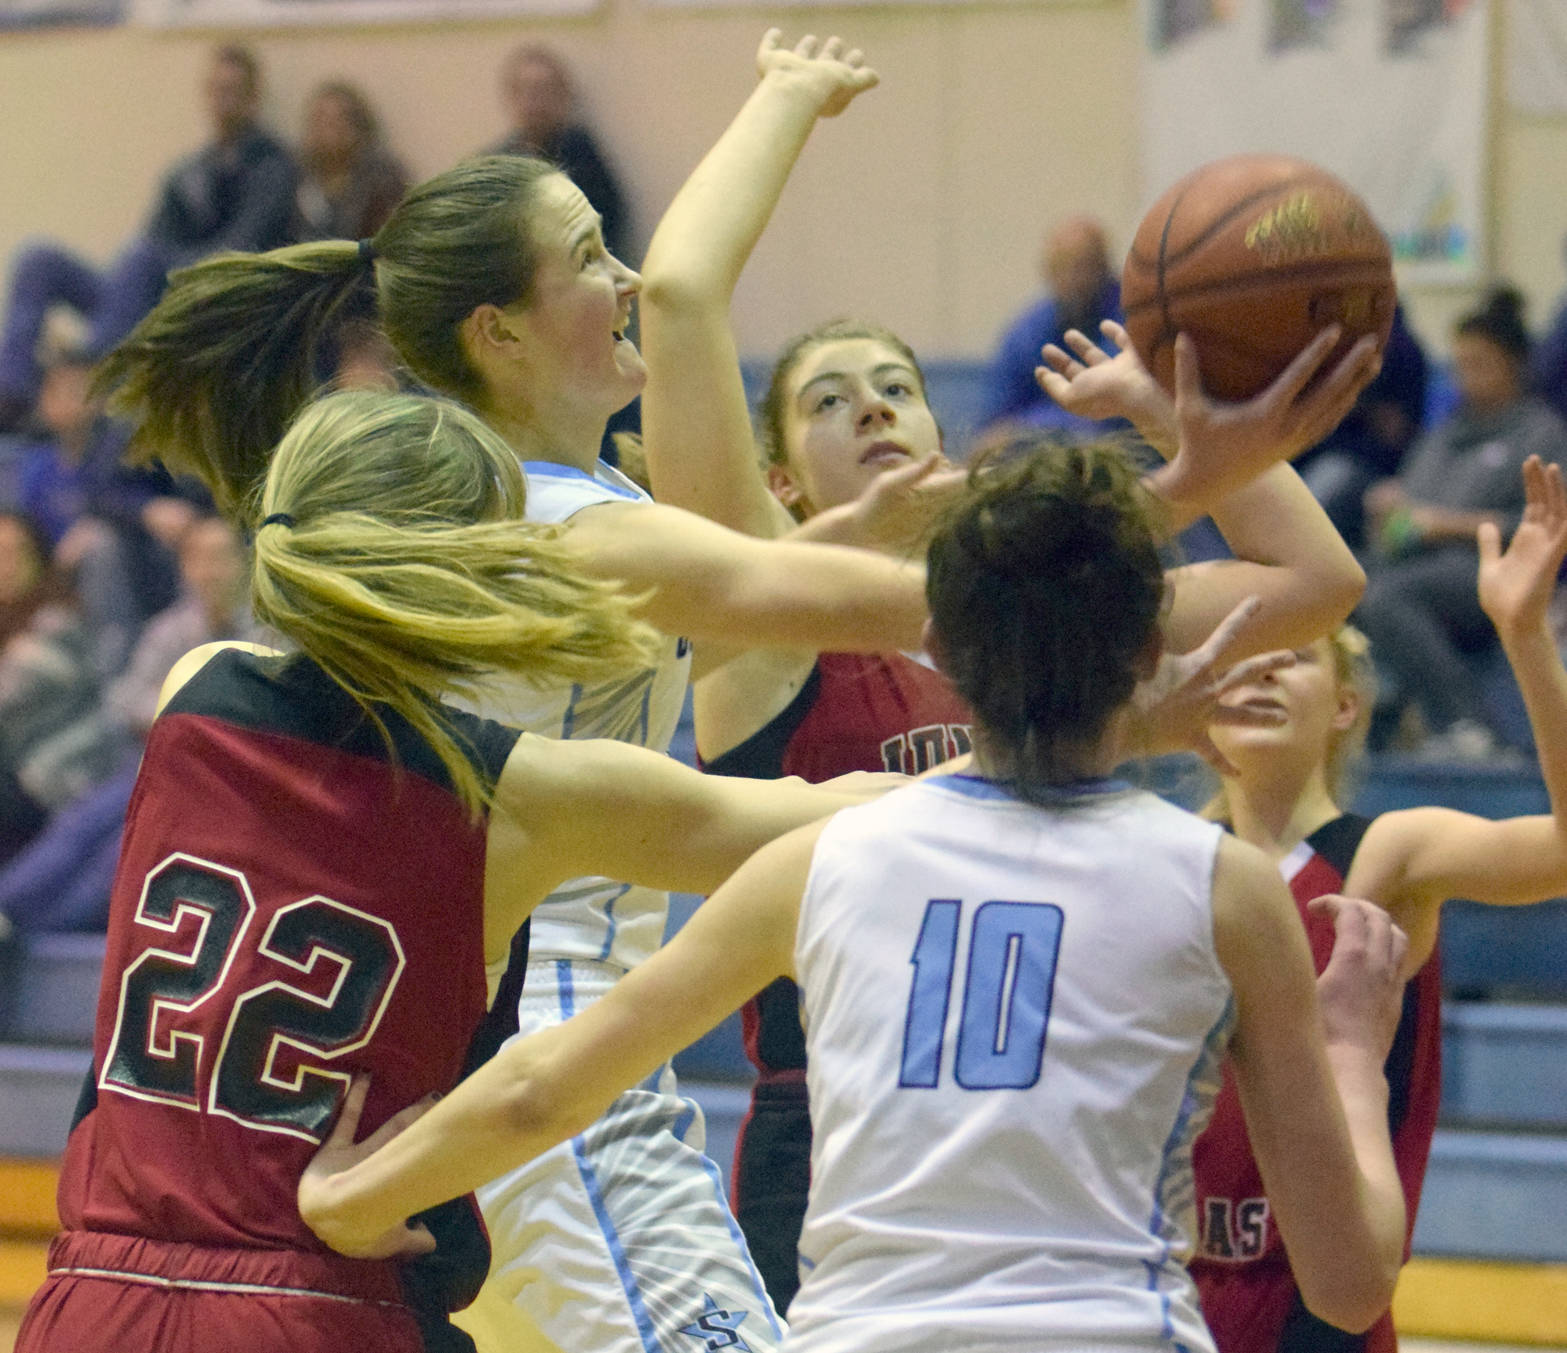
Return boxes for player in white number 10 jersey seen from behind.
[299,435,1404,1353]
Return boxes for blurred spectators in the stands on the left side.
[0,34,630,942]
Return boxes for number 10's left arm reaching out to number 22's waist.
[299,828,818,1256]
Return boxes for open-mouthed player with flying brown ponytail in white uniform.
[94,50,1366,1353]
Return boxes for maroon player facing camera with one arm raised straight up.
[642,30,1370,1309]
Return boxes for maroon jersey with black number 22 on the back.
[60,649,517,1335]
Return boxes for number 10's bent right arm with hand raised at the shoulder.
[1213,839,1406,1331]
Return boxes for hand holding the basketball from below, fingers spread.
[1156,325,1382,508]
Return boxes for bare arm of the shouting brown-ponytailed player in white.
[566,503,926,652]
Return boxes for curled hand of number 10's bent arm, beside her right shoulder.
[1310,892,1409,1065]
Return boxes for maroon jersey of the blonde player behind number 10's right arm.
[1191,814,1442,1353]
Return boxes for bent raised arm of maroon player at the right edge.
[1346,456,1567,964]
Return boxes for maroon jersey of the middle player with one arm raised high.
[702,654,973,1082]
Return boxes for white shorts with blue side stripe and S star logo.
[478,959,784,1353]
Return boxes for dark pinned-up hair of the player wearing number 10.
[926,436,1164,803]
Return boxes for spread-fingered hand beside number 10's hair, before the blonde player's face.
[1133,597,1294,774]
